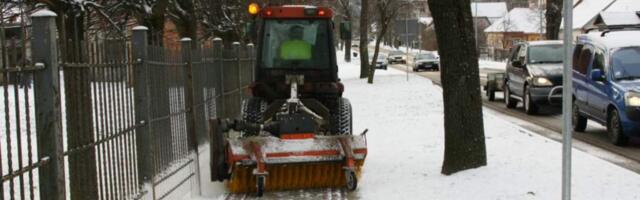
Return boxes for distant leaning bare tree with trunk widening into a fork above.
[367,0,401,84]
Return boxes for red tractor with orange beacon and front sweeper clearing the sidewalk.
[210,4,367,196]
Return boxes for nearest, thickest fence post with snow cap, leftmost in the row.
[31,9,66,200]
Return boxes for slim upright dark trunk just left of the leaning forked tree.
[360,0,369,78]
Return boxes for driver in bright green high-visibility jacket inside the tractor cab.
[280,25,312,60]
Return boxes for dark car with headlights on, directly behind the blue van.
[504,41,563,115]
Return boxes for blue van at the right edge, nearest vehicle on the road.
[572,30,640,146]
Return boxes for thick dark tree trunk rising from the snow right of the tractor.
[429,0,487,175]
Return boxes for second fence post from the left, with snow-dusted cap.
[131,26,155,185]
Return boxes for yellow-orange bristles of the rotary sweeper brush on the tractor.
[226,160,364,193]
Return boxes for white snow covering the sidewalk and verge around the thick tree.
[191,50,640,199]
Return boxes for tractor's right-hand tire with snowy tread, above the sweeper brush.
[331,98,353,135]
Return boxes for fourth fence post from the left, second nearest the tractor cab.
[213,38,227,119]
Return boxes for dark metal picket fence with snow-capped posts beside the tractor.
[0,10,255,199]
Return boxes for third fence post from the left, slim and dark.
[180,38,204,195]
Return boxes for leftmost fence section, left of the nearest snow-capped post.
[0,3,42,199]
